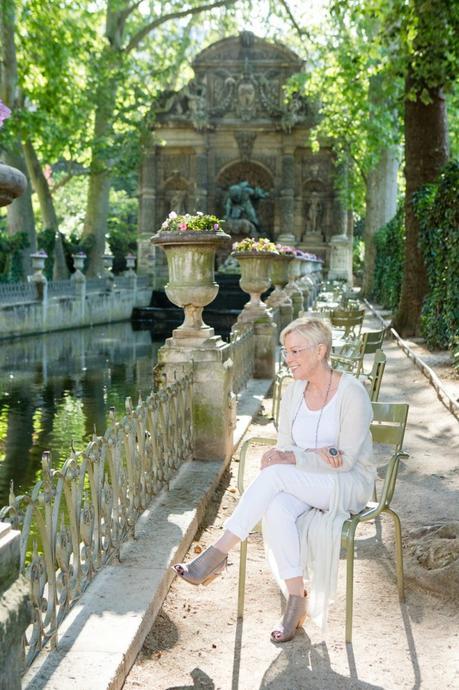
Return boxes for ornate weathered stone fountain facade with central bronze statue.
[138,32,352,282]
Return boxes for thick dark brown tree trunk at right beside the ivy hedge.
[394,73,448,337]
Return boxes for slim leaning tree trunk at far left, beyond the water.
[23,140,69,280]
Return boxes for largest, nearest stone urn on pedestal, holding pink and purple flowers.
[151,230,231,339]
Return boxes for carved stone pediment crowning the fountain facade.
[156,31,314,132]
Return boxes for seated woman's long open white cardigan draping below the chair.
[263,374,376,630]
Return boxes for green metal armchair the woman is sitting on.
[237,403,409,642]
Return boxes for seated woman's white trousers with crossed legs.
[225,465,334,580]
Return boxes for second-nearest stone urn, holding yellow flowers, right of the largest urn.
[233,252,274,321]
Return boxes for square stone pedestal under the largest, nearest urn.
[155,335,236,463]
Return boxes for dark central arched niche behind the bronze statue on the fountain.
[215,160,275,237]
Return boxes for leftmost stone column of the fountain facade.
[137,141,158,275]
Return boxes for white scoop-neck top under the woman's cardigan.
[292,390,341,450]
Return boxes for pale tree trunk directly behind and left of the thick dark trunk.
[362,146,399,296]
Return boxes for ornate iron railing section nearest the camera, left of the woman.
[0,375,192,665]
